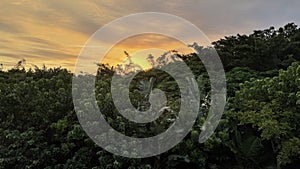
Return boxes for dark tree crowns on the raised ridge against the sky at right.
[213,23,300,71]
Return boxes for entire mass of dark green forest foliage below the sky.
[0,24,300,169]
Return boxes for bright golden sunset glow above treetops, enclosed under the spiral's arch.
[101,33,193,69]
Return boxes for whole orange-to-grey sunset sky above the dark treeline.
[0,0,300,71]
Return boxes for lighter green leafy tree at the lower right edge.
[228,62,300,166]
